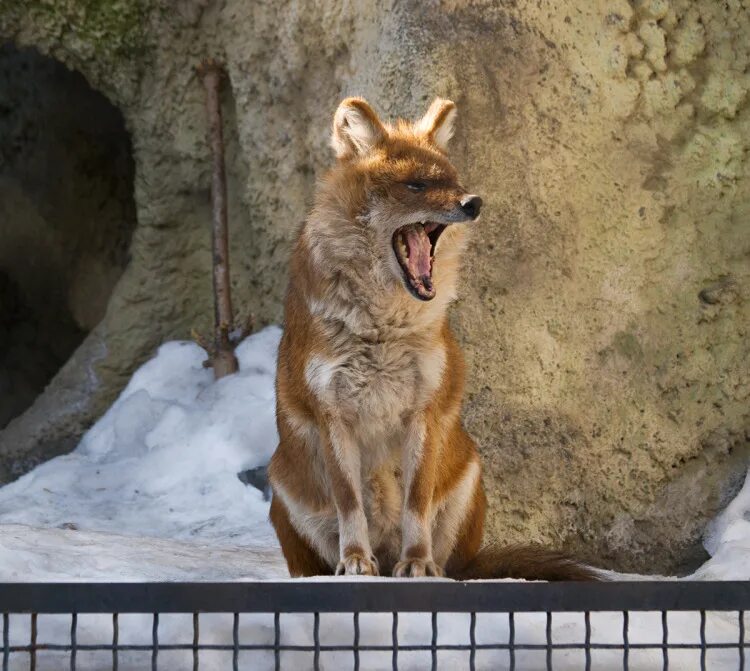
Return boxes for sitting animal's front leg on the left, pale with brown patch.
[324,419,379,575]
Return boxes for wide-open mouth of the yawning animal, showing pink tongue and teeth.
[392,221,445,301]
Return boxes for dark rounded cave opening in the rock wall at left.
[0,44,136,430]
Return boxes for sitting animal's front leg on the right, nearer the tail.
[393,416,443,578]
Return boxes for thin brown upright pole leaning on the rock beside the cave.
[198,60,239,380]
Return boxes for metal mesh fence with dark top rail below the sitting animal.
[0,579,750,671]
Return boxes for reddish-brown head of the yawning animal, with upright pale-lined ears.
[312,98,482,301]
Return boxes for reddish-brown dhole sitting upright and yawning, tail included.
[269,98,596,580]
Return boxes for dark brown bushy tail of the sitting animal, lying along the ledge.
[448,545,604,581]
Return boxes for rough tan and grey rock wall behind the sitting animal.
[0,0,750,571]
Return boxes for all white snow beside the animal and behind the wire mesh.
[0,327,750,670]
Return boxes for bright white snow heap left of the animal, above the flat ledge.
[0,327,281,552]
